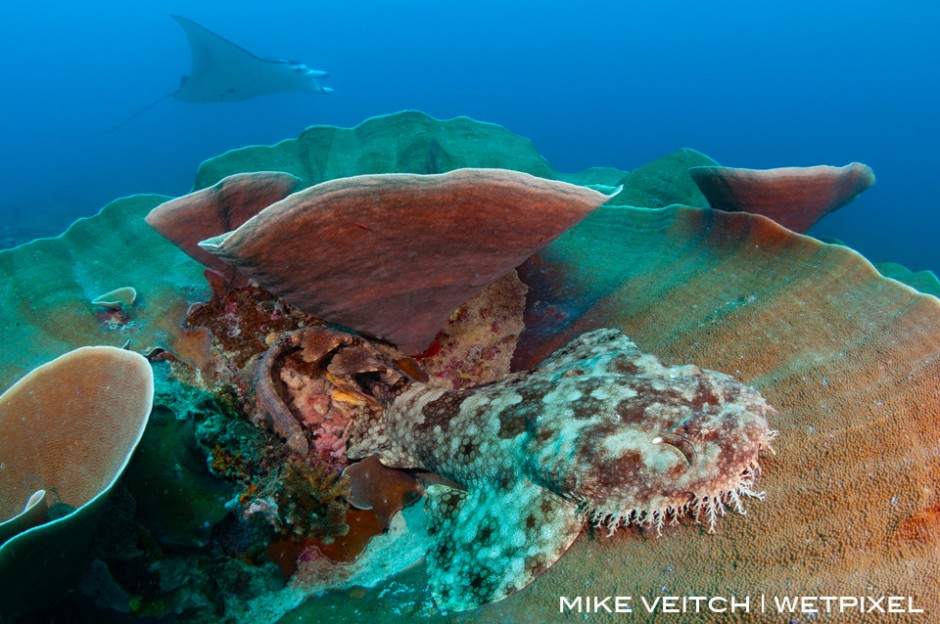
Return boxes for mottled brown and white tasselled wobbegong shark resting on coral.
[258,329,773,611]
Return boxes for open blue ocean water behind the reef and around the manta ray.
[0,0,940,271]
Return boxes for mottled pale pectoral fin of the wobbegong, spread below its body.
[427,479,582,611]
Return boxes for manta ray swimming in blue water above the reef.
[115,15,333,129]
